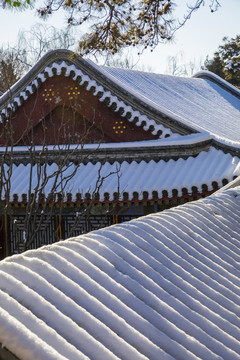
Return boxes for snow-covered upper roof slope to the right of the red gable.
[101,67,240,141]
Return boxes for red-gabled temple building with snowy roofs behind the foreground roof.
[0,50,240,257]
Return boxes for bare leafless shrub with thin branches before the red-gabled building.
[0,91,119,252]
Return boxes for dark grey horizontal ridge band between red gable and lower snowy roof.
[0,137,213,164]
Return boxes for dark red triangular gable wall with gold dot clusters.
[0,76,157,145]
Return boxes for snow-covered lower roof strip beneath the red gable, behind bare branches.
[5,147,240,201]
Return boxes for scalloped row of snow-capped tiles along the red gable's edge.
[0,61,173,139]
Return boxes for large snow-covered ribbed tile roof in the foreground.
[0,188,240,360]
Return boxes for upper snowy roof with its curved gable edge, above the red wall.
[0,50,240,146]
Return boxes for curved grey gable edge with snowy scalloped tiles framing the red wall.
[0,50,180,138]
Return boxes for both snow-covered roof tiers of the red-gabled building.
[0,50,240,204]
